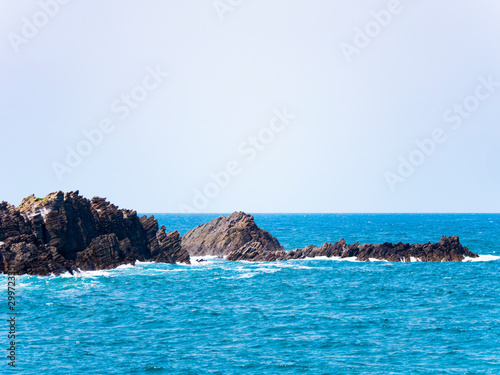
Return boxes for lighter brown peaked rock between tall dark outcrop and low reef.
[182,212,284,256]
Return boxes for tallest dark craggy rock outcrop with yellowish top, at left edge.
[0,191,189,275]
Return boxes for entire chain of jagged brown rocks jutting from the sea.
[0,191,478,276]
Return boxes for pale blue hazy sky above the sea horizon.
[0,0,500,213]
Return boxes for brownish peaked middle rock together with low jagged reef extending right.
[182,212,478,262]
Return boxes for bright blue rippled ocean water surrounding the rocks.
[0,214,500,375]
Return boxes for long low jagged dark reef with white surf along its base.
[227,236,478,262]
